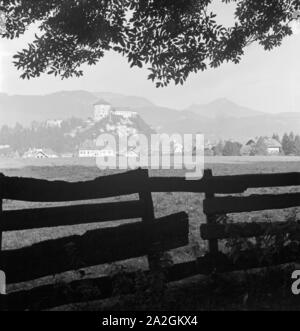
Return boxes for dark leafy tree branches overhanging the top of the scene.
[0,0,300,87]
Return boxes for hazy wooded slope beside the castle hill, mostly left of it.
[0,116,154,155]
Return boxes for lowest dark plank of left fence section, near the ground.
[6,261,198,311]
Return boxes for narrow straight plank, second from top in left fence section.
[0,201,143,231]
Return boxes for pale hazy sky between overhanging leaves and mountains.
[0,0,300,112]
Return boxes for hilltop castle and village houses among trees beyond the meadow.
[0,99,300,159]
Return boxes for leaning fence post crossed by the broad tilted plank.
[139,169,162,271]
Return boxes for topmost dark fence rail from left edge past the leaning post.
[0,169,246,202]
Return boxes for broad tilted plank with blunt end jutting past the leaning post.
[2,213,189,283]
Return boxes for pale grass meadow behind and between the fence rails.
[0,157,300,310]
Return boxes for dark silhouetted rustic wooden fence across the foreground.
[0,169,300,310]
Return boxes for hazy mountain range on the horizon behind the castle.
[0,91,300,140]
